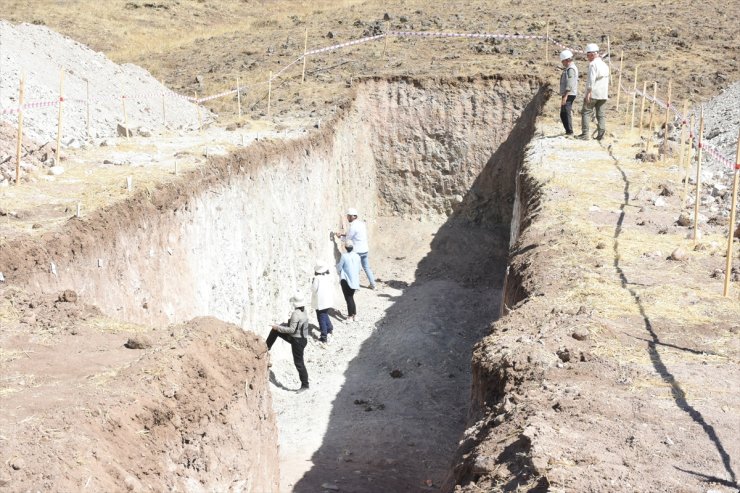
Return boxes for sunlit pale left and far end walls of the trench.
[0,77,542,333]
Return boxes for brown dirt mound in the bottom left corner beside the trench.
[0,288,278,492]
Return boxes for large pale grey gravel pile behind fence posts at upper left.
[0,21,211,147]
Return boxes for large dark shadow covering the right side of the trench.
[292,86,544,493]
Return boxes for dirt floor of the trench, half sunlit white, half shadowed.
[270,218,508,492]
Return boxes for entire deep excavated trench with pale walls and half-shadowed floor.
[0,77,546,492]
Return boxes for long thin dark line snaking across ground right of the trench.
[607,146,738,487]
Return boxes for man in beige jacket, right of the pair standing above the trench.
[578,43,609,140]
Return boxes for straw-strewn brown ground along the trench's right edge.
[445,119,740,493]
